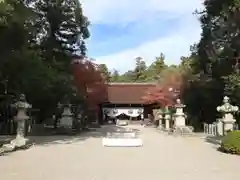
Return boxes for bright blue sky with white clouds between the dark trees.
[80,0,202,72]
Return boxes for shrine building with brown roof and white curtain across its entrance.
[99,83,156,121]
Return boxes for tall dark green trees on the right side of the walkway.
[182,0,240,127]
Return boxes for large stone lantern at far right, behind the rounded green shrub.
[217,96,239,133]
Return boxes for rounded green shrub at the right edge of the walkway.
[220,130,240,155]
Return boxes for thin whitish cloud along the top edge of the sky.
[80,0,202,24]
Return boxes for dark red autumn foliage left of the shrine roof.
[72,59,107,110]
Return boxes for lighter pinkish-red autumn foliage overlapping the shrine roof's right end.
[142,68,183,106]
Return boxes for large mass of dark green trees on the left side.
[0,0,90,122]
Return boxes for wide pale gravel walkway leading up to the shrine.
[0,127,240,180]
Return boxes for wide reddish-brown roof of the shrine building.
[107,83,156,104]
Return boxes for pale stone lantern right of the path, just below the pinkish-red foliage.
[174,99,186,127]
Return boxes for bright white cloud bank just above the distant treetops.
[94,16,200,72]
